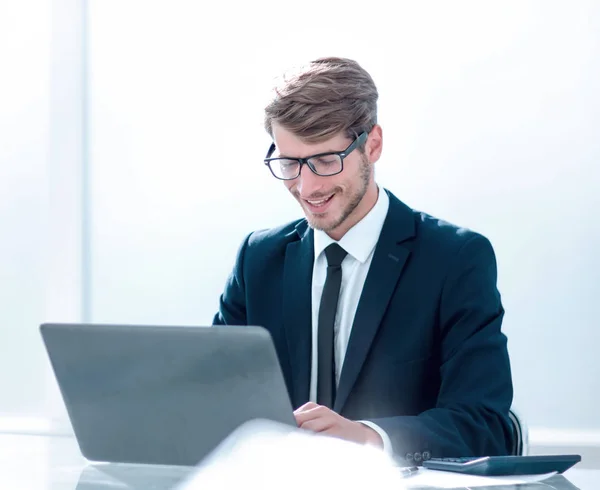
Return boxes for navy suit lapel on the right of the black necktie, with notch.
[334,191,415,413]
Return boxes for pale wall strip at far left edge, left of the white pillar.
[0,0,55,424]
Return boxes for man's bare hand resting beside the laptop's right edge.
[294,402,383,448]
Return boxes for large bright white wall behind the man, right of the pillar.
[90,0,600,429]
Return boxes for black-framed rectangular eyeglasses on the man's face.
[264,132,368,180]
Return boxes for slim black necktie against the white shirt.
[317,243,348,408]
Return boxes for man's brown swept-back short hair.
[265,58,379,143]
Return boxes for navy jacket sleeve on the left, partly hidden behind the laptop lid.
[212,234,252,325]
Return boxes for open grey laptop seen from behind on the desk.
[40,323,296,466]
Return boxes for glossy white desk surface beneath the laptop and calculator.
[0,434,600,490]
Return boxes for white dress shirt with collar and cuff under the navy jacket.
[310,188,392,454]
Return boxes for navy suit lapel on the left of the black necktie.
[283,221,314,408]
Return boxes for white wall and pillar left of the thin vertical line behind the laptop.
[0,0,84,432]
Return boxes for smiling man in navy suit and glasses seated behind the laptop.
[214,58,513,464]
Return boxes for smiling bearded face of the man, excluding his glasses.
[273,124,379,240]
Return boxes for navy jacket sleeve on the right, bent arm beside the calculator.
[373,234,513,463]
